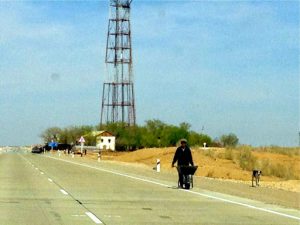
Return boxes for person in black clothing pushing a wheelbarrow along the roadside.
[172,139,194,188]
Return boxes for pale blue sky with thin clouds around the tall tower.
[0,0,300,146]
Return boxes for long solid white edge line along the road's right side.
[46,156,300,221]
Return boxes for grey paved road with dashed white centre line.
[0,150,300,225]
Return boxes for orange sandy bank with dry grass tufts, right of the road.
[82,146,300,191]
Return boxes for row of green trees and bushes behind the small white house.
[41,120,238,150]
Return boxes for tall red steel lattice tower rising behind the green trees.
[100,0,136,126]
